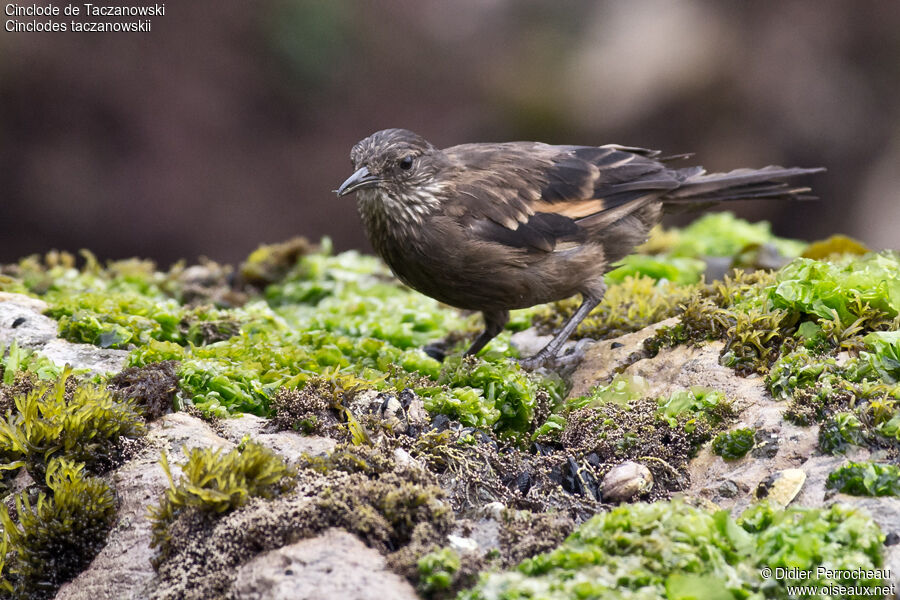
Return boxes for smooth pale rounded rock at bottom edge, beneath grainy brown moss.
[229,529,418,600]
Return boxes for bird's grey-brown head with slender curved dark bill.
[335,129,446,200]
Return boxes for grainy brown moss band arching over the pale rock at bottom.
[148,447,454,599]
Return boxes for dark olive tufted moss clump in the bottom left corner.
[0,458,116,600]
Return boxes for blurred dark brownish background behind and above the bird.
[0,0,900,266]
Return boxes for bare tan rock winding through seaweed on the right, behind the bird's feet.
[570,319,900,587]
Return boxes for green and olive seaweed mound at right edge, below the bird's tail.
[645,252,900,380]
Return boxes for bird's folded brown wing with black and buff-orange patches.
[444,142,681,252]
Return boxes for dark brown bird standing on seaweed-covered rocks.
[335,129,824,368]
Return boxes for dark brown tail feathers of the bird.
[662,166,825,208]
